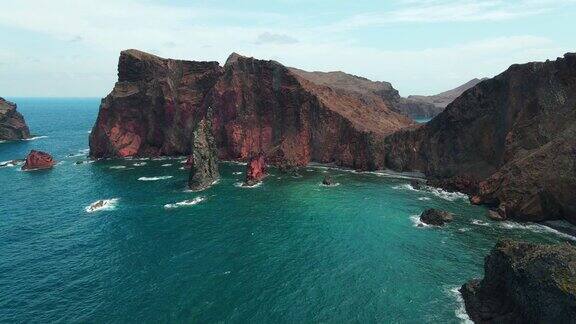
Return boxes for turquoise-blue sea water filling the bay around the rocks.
[0,98,566,323]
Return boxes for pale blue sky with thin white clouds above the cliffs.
[0,0,576,97]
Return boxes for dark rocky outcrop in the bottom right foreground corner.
[460,241,576,323]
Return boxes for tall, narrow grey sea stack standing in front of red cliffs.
[188,119,220,190]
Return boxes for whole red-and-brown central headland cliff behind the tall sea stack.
[90,50,412,169]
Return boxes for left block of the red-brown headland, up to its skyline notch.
[90,50,222,158]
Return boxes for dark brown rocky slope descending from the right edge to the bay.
[386,54,576,222]
